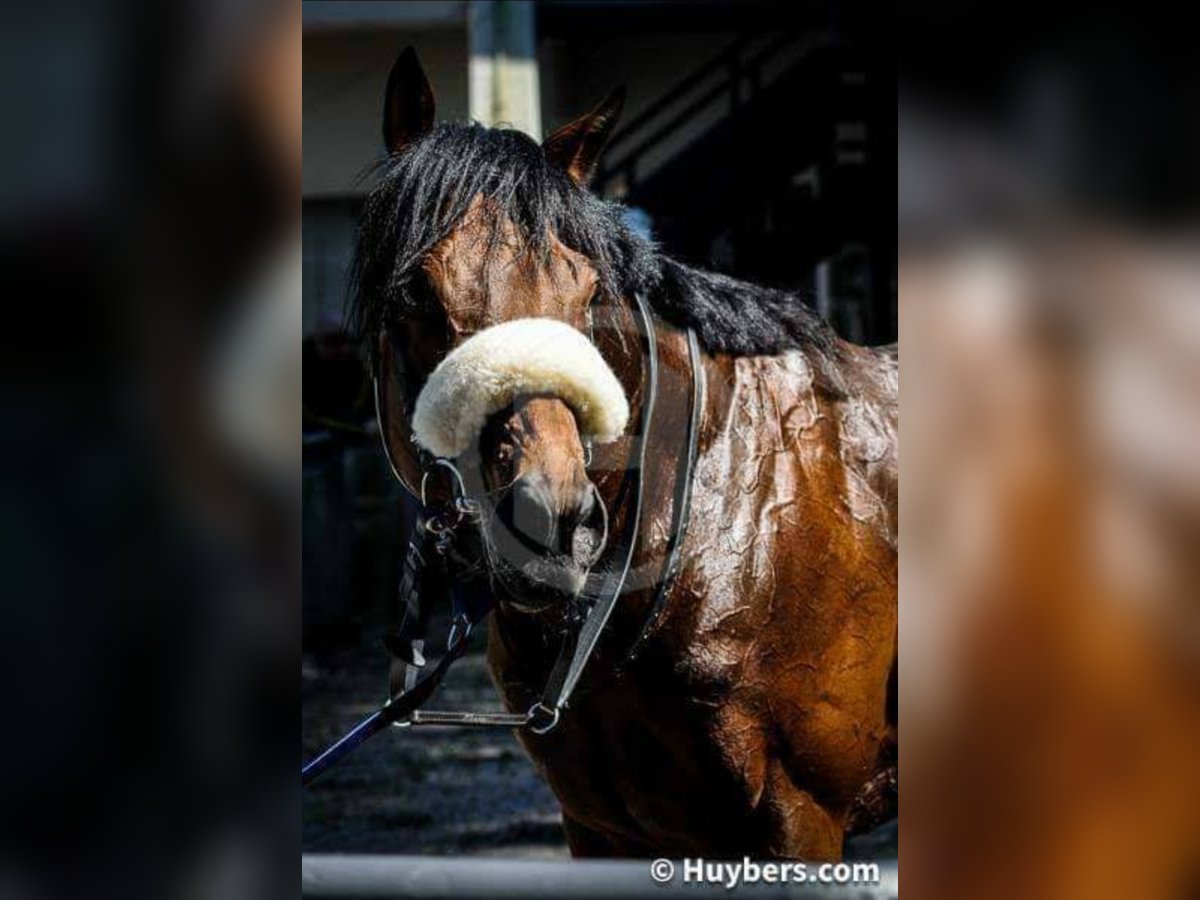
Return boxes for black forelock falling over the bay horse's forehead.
[349,124,655,360]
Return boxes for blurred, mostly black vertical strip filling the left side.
[0,0,301,898]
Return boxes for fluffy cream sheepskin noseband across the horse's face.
[413,319,629,458]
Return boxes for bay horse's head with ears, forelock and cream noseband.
[356,50,629,612]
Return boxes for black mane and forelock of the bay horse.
[349,125,834,355]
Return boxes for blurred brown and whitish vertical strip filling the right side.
[898,2,1200,899]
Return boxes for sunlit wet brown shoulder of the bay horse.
[682,353,895,840]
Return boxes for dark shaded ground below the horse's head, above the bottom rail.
[302,635,568,859]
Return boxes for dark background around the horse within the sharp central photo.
[302,0,896,857]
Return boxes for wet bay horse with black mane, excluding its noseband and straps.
[350,49,898,859]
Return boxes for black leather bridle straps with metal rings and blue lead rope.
[301,294,706,785]
